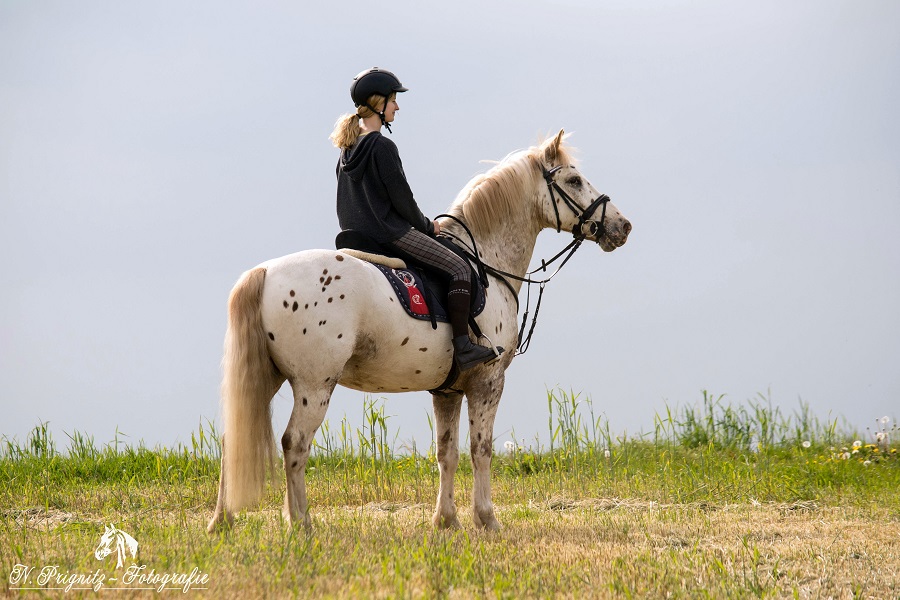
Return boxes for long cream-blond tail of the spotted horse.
[221,267,283,512]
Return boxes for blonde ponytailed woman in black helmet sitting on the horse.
[331,67,496,370]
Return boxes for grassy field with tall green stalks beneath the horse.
[0,390,900,598]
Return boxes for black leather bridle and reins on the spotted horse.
[437,165,610,356]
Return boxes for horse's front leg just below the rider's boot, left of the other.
[432,394,462,529]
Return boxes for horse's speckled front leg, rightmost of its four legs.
[466,378,504,531]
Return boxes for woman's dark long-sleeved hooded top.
[336,131,434,244]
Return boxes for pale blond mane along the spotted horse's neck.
[448,136,574,235]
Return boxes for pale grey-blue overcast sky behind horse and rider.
[0,0,900,447]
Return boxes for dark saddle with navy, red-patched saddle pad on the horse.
[335,229,487,336]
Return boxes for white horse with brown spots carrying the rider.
[207,130,631,533]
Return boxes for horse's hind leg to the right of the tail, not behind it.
[281,377,337,528]
